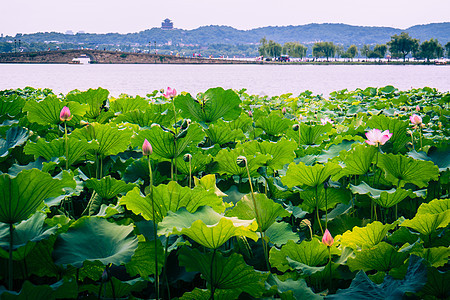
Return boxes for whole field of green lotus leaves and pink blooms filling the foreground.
[0,86,450,299]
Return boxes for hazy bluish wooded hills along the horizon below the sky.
[4,22,450,45]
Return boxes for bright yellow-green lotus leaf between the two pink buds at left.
[70,123,132,157]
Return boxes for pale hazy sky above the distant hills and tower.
[0,0,450,35]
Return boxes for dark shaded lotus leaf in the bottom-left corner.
[0,278,78,300]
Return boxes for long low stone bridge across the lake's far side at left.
[0,50,263,64]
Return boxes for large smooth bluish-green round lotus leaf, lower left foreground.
[53,217,138,268]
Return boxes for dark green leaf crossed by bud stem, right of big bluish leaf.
[125,240,164,278]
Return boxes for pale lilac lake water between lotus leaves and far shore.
[0,64,450,96]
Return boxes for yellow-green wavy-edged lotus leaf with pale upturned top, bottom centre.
[158,206,258,249]
